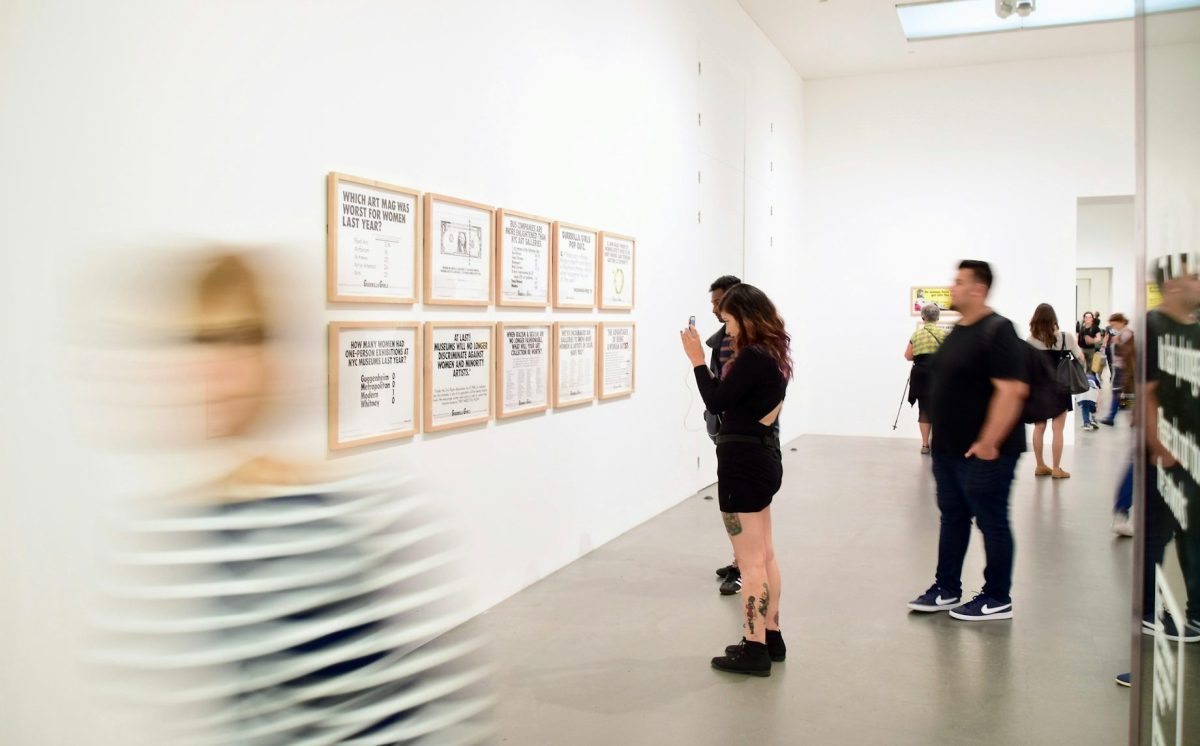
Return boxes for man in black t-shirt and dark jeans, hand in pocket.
[908,260,1030,621]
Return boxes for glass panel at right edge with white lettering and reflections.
[1134,4,1200,746]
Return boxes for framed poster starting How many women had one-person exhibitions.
[328,321,422,451]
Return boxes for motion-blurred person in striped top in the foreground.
[90,251,492,746]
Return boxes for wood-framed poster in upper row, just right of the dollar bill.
[496,210,554,308]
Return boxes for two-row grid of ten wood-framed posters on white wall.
[326,173,637,450]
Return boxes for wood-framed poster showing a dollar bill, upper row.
[425,194,496,306]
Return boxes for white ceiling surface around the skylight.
[738,0,1134,78]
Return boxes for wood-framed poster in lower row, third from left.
[496,323,551,419]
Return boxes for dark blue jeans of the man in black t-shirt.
[934,452,1018,603]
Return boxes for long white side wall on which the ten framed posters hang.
[0,0,803,744]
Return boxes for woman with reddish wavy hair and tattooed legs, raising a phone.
[679,283,792,676]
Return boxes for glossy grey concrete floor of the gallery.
[469,427,1132,745]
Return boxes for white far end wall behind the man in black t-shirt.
[802,54,1134,441]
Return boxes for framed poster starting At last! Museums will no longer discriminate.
[425,321,493,433]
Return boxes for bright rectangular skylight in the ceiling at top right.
[896,0,1200,40]
